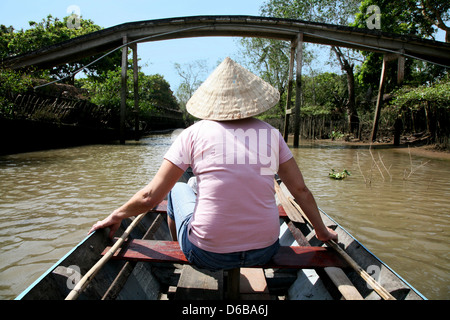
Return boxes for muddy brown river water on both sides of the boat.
[0,134,450,300]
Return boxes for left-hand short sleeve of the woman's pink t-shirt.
[164,128,192,170]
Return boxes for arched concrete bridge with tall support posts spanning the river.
[2,16,450,147]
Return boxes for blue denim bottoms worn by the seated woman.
[167,182,280,271]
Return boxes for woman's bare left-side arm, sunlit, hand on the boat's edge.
[89,159,184,238]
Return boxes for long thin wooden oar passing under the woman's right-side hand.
[289,197,395,300]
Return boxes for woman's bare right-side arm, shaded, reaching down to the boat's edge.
[278,158,337,242]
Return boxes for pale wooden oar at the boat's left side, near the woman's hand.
[66,213,146,300]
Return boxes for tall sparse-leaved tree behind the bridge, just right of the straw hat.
[248,0,359,131]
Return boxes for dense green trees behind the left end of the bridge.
[0,15,178,129]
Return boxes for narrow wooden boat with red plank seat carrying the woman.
[16,174,426,300]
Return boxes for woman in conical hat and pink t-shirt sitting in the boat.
[90,58,337,270]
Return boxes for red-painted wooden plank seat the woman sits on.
[102,239,347,269]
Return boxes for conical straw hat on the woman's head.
[186,58,280,121]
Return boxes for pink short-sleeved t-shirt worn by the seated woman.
[164,118,292,253]
